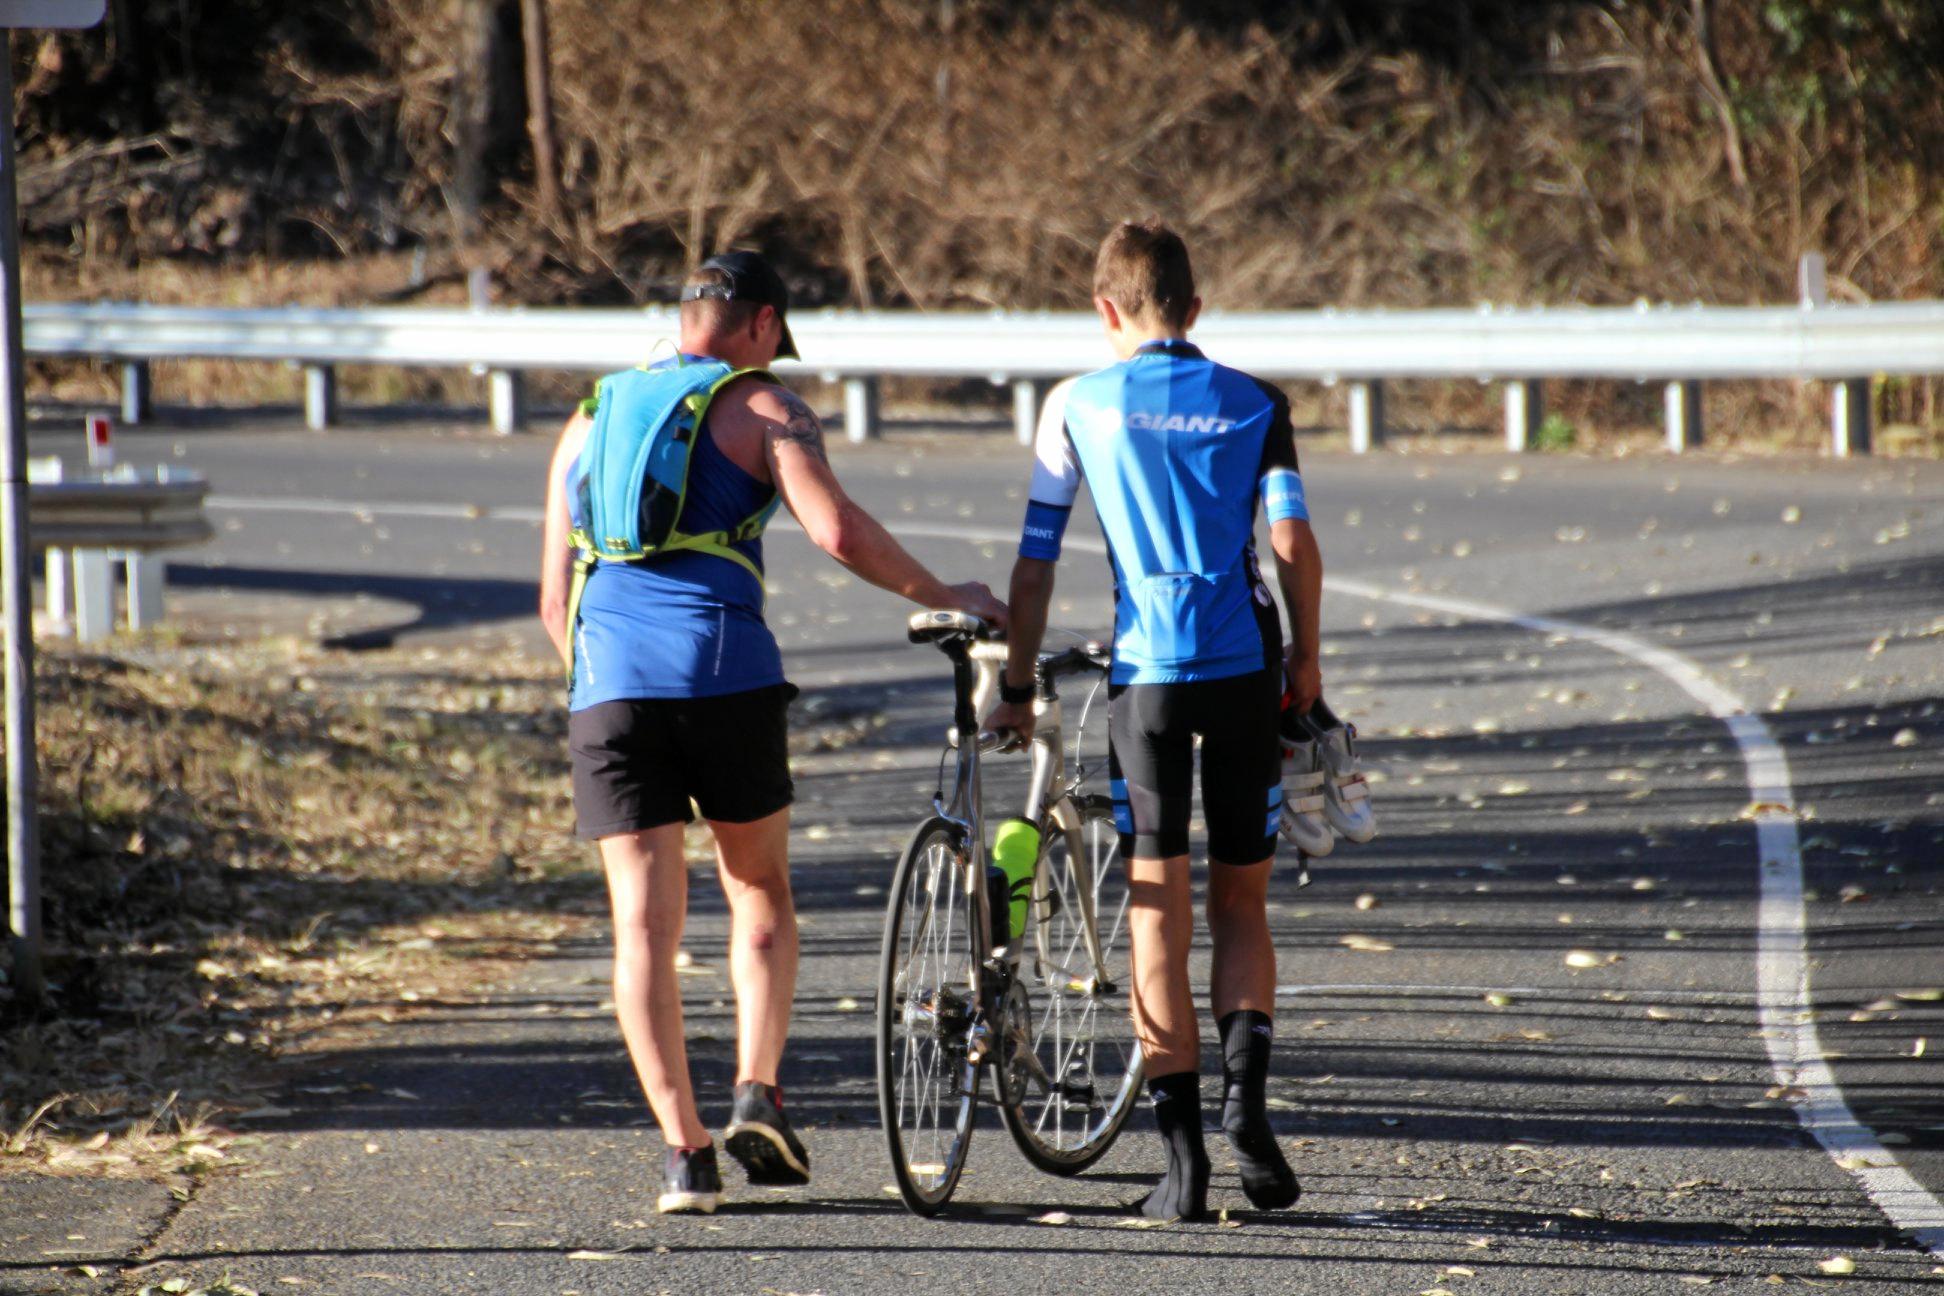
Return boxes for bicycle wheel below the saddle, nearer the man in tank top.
[877,816,982,1214]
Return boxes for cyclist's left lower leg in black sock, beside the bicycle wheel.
[1128,855,1209,1218]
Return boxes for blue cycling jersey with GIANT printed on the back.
[1019,340,1308,684]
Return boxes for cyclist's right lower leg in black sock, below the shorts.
[1209,857,1302,1211]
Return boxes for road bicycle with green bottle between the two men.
[877,610,1141,1216]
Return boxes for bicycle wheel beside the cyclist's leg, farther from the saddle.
[999,797,1143,1174]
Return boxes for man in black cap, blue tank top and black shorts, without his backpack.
[540,253,1005,1211]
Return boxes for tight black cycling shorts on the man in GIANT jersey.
[1106,668,1283,865]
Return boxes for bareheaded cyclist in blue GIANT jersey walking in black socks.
[986,223,1322,1218]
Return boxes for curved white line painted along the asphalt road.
[208,495,1944,1257]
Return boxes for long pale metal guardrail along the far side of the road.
[25,301,1944,455]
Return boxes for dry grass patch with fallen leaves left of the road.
[0,645,603,1176]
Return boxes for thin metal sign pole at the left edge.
[0,40,47,1006]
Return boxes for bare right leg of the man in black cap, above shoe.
[710,808,797,1084]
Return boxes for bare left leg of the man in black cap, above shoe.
[601,824,710,1148]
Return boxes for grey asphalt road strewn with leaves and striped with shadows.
[15,409,1944,1294]
